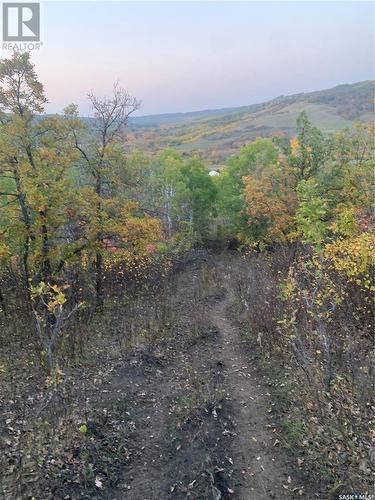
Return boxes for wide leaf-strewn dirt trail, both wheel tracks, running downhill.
[105,257,312,500]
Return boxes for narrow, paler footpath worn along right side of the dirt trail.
[212,263,300,500]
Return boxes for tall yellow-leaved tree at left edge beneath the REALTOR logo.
[0,49,76,290]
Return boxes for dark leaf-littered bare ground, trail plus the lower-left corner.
[0,252,316,500]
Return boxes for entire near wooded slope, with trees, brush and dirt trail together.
[0,53,375,500]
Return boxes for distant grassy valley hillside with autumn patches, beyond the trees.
[129,81,374,164]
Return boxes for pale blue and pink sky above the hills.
[6,1,375,115]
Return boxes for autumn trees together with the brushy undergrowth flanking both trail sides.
[0,49,375,488]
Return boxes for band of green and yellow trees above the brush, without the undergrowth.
[0,53,374,376]
